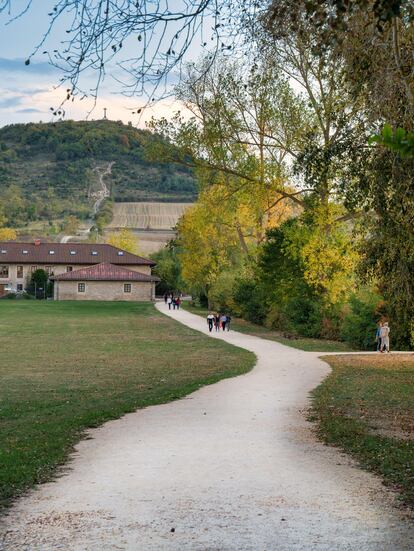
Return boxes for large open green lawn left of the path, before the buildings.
[0,300,255,508]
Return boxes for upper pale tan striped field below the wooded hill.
[108,203,191,230]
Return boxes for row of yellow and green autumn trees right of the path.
[153,5,414,349]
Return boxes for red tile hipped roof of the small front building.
[51,262,160,282]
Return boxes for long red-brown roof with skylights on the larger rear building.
[0,241,155,266]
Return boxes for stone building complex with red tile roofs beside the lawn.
[0,240,159,300]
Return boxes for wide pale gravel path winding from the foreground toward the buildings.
[0,304,414,551]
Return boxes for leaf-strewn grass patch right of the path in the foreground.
[311,354,414,507]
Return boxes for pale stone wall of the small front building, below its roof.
[54,281,154,301]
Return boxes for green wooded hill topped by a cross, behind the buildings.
[0,120,196,226]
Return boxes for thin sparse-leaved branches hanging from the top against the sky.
[0,0,258,108]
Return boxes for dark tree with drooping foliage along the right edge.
[268,0,414,346]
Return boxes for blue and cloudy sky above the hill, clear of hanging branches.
[0,0,207,127]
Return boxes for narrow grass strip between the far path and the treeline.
[182,302,353,352]
